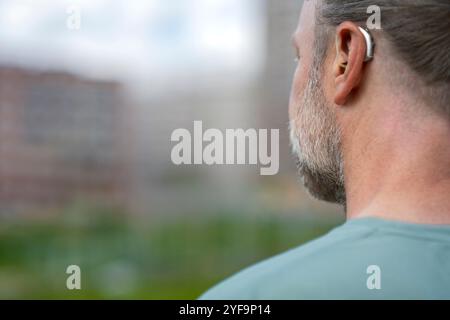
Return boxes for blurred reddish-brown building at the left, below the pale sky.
[0,66,128,214]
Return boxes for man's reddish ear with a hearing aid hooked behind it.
[333,21,366,105]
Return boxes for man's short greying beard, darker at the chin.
[290,66,346,205]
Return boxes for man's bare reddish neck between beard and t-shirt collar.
[344,101,450,224]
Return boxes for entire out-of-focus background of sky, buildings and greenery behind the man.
[0,0,344,299]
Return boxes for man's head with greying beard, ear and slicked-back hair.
[289,0,450,204]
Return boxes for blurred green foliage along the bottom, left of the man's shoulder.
[0,204,338,299]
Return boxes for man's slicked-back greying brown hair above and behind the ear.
[316,0,450,116]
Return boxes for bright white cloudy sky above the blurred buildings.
[0,0,264,82]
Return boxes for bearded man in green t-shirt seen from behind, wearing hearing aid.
[201,0,450,299]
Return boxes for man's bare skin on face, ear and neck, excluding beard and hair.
[289,0,450,224]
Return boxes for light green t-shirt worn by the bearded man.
[200,218,450,300]
